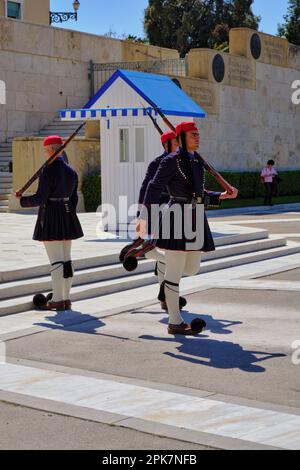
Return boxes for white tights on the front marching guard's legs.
[146,248,201,325]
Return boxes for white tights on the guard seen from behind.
[44,241,73,302]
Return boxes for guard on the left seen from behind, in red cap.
[16,134,83,310]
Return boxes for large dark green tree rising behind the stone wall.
[144,0,260,56]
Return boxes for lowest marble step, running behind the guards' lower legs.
[0,242,300,316]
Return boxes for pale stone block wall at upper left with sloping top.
[0,18,178,142]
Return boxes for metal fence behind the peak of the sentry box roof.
[89,59,188,98]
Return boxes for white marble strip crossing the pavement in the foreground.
[0,363,300,450]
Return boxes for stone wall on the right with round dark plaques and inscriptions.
[183,28,300,171]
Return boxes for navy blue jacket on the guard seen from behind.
[20,157,78,208]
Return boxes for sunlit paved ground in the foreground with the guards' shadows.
[0,213,300,449]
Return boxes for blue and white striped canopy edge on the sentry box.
[60,108,158,121]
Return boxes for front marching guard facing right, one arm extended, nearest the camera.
[136,122,238,335]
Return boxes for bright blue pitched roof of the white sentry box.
[84,70,206,118]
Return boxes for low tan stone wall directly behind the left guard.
[10,137,101,212]
